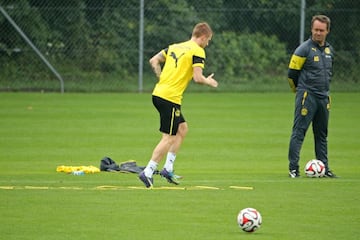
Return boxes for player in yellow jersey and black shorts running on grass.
[139,22,218,188]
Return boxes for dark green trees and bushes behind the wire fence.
[0,0,360,92]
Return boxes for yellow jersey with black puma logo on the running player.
[152,40,205,105]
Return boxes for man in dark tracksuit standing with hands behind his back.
[288,15,336,178]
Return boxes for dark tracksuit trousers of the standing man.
[288,91,330,171]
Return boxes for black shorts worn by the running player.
[152,96,185,135]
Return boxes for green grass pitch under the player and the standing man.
[0,92,360,240]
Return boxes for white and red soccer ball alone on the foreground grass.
[237,208,262,232]
